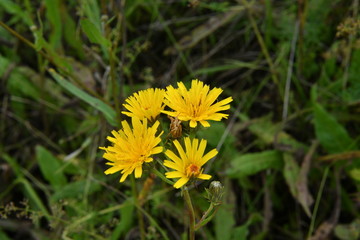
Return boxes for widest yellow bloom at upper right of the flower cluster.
[162,79,233,128]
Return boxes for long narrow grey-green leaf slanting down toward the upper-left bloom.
[49,69,117,126]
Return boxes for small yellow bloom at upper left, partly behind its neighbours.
[121,88,165,121]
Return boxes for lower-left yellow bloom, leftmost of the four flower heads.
[100,117,163,182]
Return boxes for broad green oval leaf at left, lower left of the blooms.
[36,146,67,188]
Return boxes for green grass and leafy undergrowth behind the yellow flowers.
[0,0,360,240]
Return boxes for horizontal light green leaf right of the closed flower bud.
[227,151,283,178]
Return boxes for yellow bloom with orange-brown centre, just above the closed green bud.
[164,137,218,188]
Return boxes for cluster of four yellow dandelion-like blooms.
[100,80,232,188]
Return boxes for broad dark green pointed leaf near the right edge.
[313,98,355,153]
